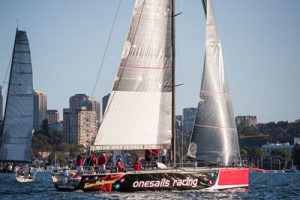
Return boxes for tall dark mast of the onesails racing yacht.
[171,0,176,166]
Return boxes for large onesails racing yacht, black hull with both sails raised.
[52,0,249,192]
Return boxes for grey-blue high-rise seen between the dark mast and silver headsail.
[182,108,197,134]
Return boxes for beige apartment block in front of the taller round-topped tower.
[75,107,99,146]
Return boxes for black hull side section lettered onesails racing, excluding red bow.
[78,170,218,192]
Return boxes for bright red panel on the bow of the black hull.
[218,168,249,185]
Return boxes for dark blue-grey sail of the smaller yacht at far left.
[0,30,33,162]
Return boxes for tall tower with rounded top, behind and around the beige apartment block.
[64,94,100,143]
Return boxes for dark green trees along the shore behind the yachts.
[32,120,300,169]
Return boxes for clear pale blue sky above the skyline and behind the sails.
[0,0,300,123]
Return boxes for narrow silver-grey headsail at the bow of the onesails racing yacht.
[188,0,240,166]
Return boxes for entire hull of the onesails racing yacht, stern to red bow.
[52,168,249,192]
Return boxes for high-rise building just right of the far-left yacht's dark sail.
[33,90,47,129]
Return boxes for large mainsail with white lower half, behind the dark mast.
[93,0,173,150]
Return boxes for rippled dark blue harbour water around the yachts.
[0,172,300,200]
